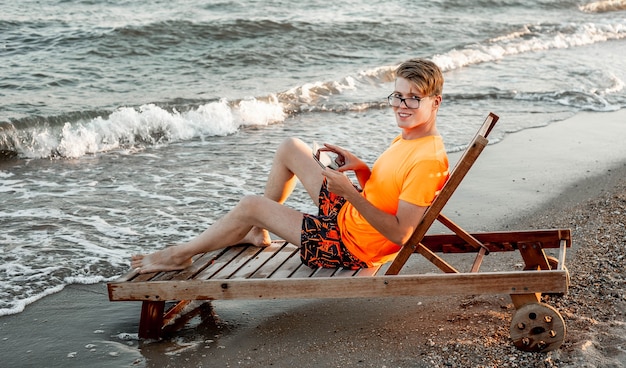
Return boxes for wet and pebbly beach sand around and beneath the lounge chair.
[0,110,626,367]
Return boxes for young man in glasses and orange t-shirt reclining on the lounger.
[131,59,448,273]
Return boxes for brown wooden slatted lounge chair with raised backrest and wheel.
[108,114,571,351]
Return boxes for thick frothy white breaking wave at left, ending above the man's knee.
[0,97,285,158]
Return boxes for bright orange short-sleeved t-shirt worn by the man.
[337,136,449,266]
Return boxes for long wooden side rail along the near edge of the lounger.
[110,270,567,301]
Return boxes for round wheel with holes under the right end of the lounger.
[511,303,565,352]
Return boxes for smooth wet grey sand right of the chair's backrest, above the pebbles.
[444,109,626,231]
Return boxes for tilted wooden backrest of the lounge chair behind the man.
[386,113,499,275]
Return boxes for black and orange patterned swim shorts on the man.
[300,179,367,270]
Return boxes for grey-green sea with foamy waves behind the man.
[0,0,626,315]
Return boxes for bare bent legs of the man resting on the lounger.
[131,138,323,273]
